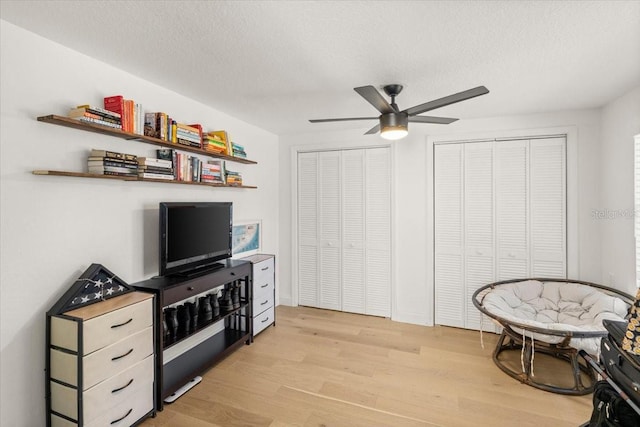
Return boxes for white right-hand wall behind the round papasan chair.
[593,87,640,295]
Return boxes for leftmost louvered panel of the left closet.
[298,153,320,307]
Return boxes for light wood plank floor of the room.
[142,306,591,427]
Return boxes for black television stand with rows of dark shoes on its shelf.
[132,259,253,410]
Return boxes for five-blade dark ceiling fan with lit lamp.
[309,84,489,140]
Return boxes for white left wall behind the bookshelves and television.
[0,21,279,427]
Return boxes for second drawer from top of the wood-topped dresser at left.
[50,326,153,390]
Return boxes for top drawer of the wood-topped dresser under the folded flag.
[51,295,153,355]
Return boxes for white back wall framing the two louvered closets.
[279,110,601,325]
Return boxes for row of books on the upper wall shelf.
[68,95,247,159]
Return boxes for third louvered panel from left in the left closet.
[342,150,366,313]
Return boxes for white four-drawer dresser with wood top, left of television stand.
[47,292,155,427]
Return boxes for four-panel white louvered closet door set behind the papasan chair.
[434,137,567,330]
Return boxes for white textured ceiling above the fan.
[0,0,640,134]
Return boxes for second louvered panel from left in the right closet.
[461,142,495,330]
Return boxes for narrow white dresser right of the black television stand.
[242,254,276,336]
